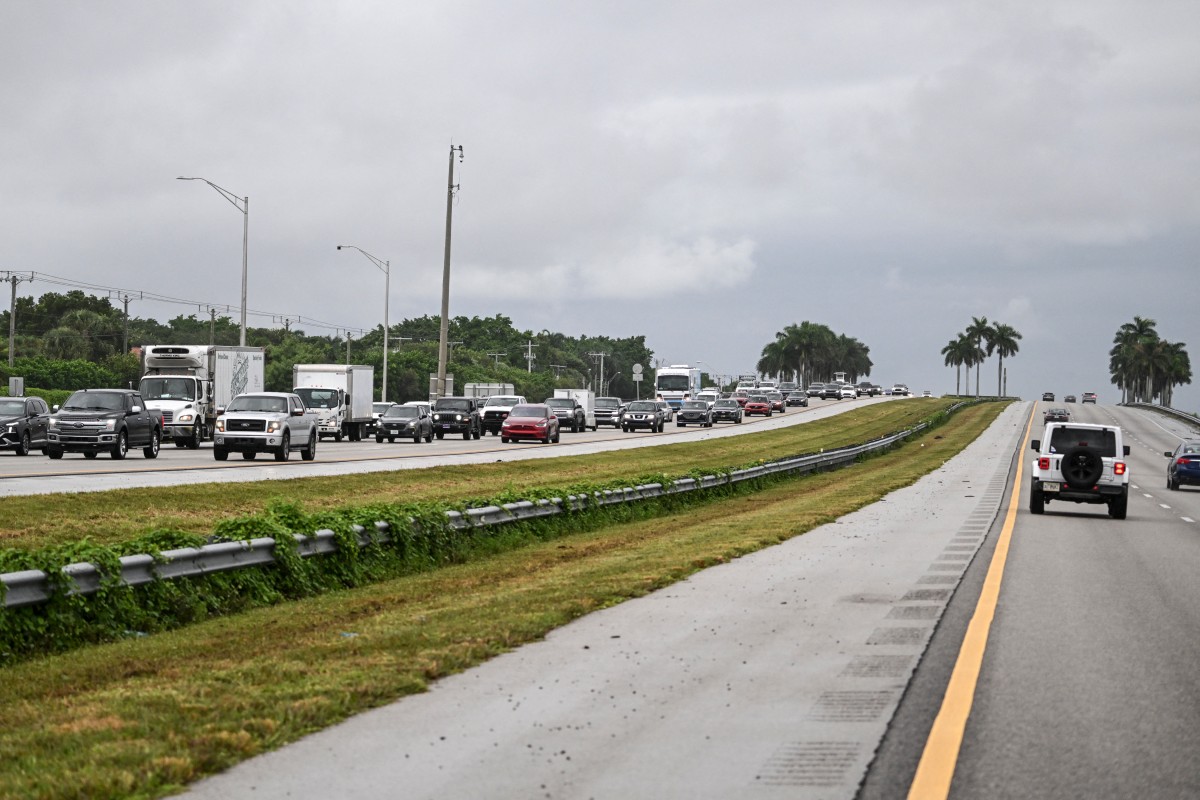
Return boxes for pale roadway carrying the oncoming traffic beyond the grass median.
[0,397,883,497]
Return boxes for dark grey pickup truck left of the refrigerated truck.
[46,389,162,458]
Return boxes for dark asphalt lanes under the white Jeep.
[860,403,1200,800]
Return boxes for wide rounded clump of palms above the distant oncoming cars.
[755,320,874,386]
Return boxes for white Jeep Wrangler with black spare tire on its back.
[1030,422,1129,519]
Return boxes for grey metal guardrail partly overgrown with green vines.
[0,417,945,608]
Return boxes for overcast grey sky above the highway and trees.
[0,0,1200,410]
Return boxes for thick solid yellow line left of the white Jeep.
[908,407,1037,800]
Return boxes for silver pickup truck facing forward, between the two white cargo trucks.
[212,392,317,461]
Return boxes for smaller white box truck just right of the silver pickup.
[292,363,374,441]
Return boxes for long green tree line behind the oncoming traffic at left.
[0,289,654,402]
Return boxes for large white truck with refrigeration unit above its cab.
[138,344,266,450]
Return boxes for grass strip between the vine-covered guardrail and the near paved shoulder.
[0,403,1003,798]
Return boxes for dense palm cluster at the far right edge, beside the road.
[1109,317,1192,405]
